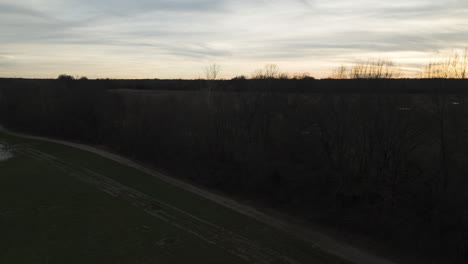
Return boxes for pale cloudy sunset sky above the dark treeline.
[0,0,468,79]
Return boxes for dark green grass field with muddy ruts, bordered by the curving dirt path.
[0,133,347,264]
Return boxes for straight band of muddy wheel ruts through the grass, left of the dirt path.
[15,148,300,264]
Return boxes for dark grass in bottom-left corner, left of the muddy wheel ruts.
[0,152,244,263]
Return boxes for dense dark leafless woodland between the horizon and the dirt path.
[0,78,468,262]
